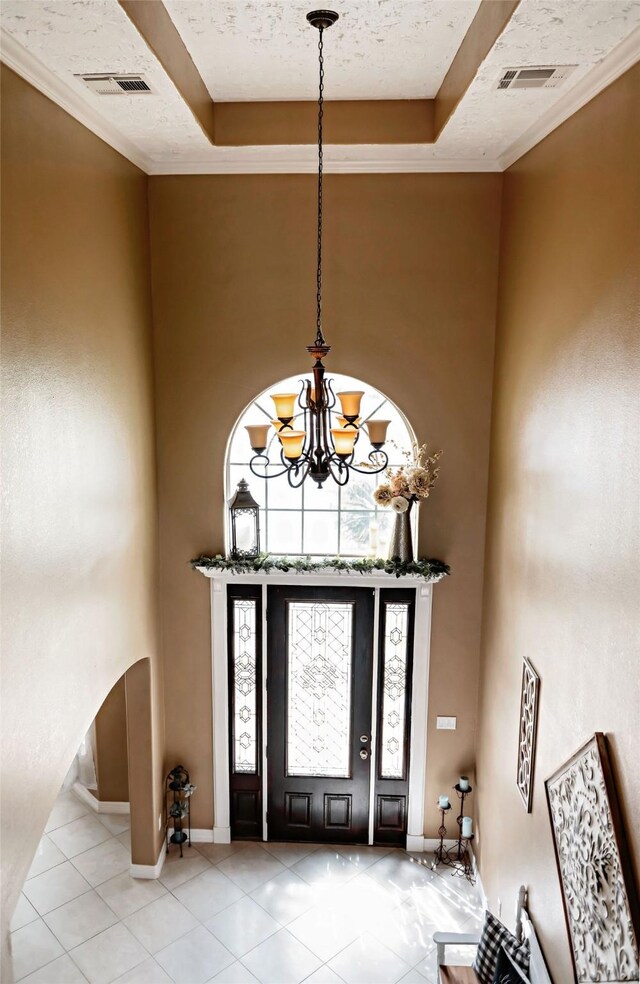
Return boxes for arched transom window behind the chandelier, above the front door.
[225,373,415,557]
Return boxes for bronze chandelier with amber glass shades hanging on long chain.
[246,10,390,488]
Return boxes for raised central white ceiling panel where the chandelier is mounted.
[164,0,480,102]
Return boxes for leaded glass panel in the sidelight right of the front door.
[380,604,409,779]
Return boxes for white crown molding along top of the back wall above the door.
[147,157,502,176]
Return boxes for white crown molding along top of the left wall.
[0,28,150,172]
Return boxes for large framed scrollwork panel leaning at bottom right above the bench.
[545,733,640,984]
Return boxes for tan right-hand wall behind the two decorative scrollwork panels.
[478,66,640,984]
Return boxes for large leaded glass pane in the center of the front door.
[287,601,353,778]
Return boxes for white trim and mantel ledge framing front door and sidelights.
[201,570,433,851]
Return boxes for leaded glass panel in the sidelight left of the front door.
[233,599,258,774]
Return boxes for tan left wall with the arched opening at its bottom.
[2,70,160,968]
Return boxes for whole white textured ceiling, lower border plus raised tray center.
[1,0,640,171]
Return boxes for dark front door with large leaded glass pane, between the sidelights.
[267,586,374,843]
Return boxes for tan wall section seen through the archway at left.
[95,677,129,803]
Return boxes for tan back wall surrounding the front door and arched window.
[150,175,501,832]
